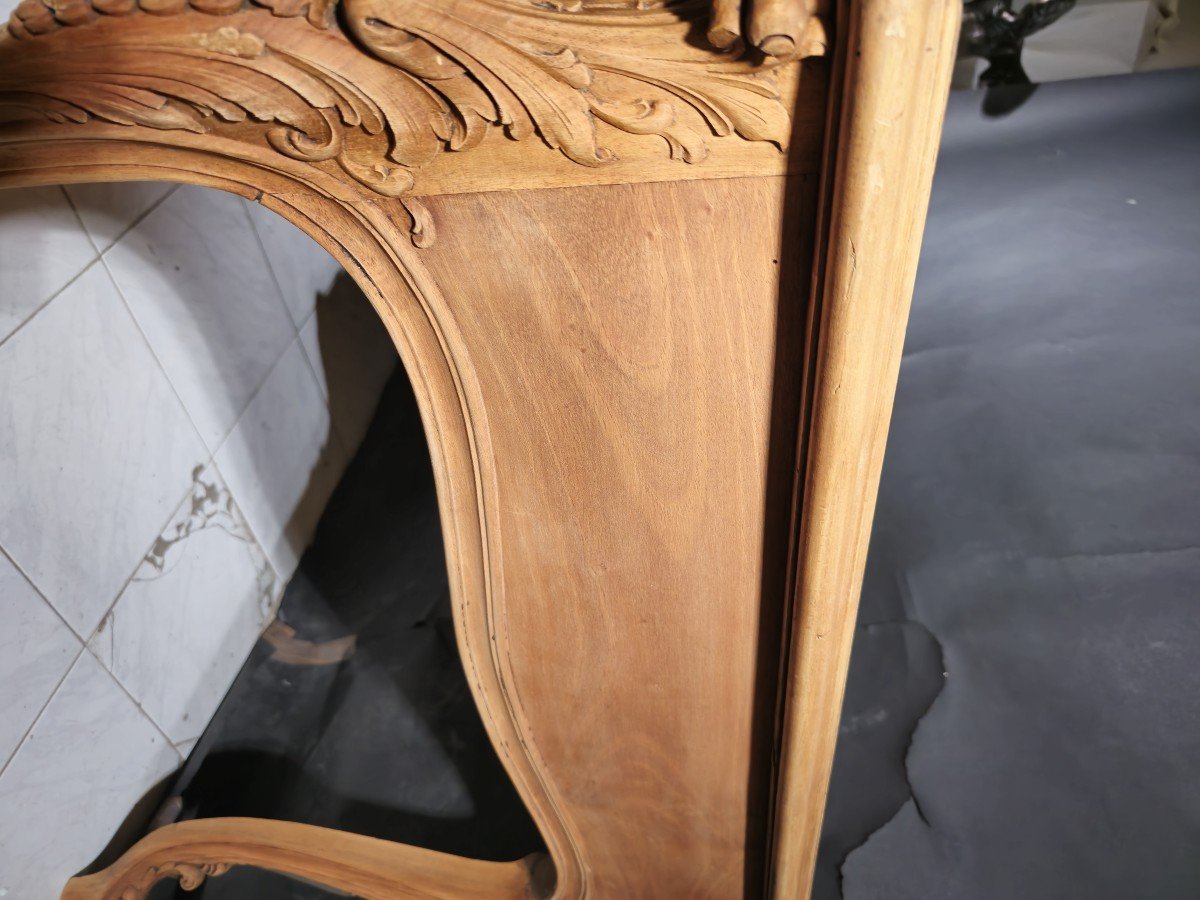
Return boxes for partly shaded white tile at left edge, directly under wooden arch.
[0,184,96,341]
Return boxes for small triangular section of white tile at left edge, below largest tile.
[0,553,80,767]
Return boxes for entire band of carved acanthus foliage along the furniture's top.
[0,0,826,246]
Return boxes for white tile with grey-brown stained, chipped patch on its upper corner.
[89,467,278,744]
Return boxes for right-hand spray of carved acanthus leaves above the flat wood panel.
[344,0,806,166]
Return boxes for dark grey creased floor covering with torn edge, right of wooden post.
[816,70,1200,900]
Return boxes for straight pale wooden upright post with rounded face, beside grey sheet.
[770,0,961,900]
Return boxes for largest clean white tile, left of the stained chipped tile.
[0,264,206,636]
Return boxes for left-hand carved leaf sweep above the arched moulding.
[0,0,427,197]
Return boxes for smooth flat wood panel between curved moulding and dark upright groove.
[412,172,811,898]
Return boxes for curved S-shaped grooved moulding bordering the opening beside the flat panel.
[0,151,586,899]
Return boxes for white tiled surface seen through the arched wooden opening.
[0,185,396,900]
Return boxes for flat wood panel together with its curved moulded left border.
[0,139,811,898]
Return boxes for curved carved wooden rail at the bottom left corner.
[62,818,538,900]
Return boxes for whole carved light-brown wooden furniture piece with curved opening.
[0,0,958,900]
